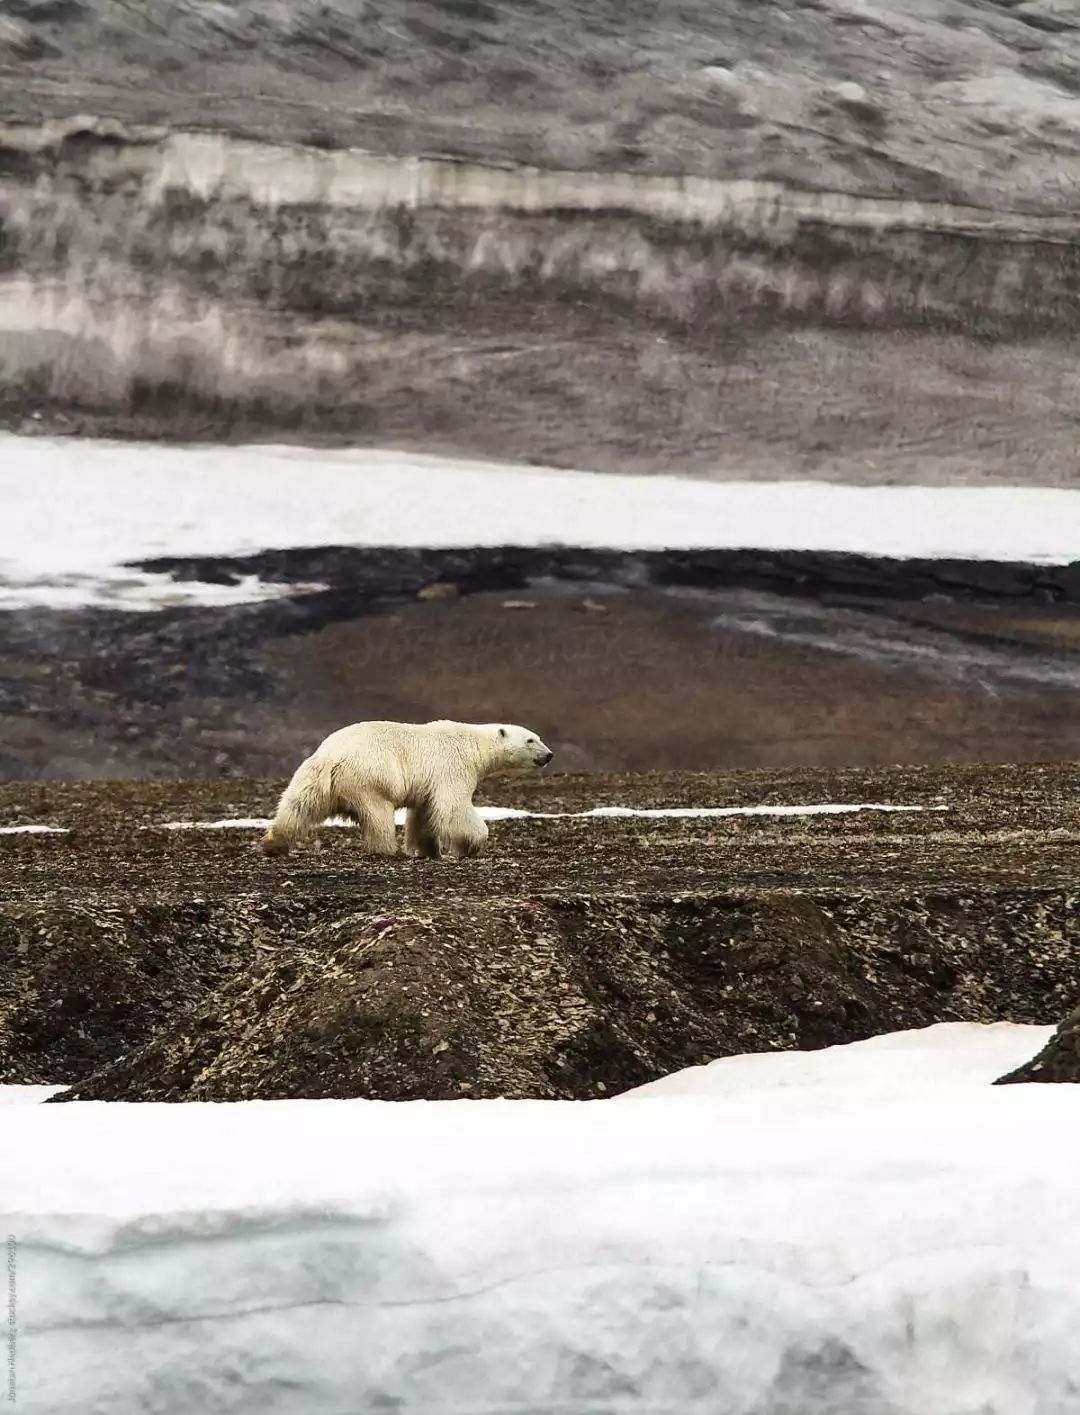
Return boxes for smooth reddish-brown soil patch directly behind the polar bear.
[270,590,1080,771]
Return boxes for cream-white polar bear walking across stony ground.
[262,722,555,859]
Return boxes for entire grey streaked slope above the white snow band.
[0,0,1080,483]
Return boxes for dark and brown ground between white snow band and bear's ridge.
[0,546,1080,781]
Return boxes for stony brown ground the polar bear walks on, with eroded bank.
[0,767,1080,1101]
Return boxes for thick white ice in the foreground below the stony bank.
[0,1024,1080,1415]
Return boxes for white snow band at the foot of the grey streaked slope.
[0,436,1080,608]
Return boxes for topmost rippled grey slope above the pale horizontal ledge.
[0,0,1080,203]
